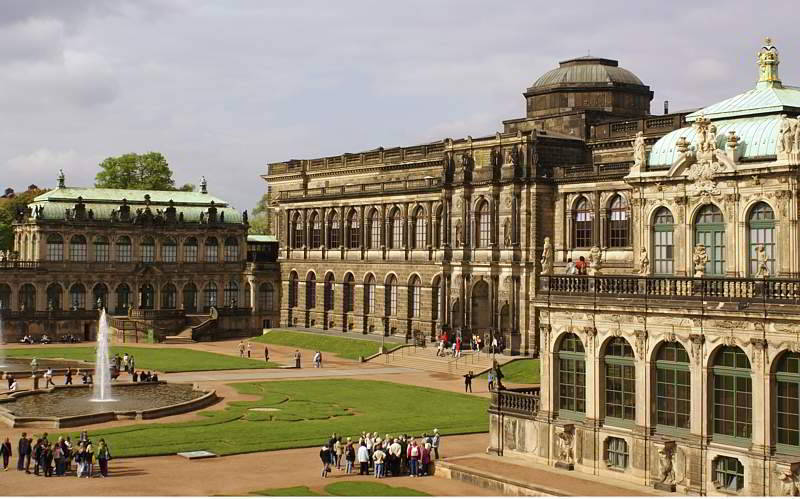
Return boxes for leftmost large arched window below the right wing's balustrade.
[556,333,586,414]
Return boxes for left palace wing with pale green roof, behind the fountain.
[0,173,280,341]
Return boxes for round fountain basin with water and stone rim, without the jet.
[0,381,217,428]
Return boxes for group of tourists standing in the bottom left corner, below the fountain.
[0,430,111,478]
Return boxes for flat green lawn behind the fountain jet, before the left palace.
[6,346,278,373]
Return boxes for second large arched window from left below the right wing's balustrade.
[603,337,636,421]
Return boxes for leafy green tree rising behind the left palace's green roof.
[94,152,189,191]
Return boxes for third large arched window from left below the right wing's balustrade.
[656,341,692,430]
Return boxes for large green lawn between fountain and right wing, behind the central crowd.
[81,379,489,457]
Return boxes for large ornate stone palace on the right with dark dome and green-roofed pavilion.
[263,40,800,495]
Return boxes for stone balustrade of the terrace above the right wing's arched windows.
[538,275,800,304]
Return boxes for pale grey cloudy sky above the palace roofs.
[0,0,800,210]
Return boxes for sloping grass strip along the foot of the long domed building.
[250,330,396,362]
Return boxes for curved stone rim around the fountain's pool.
[0,381,217,429]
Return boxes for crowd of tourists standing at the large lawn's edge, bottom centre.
[319,429,441,478]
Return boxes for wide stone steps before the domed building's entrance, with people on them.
[370,346,514,376]
